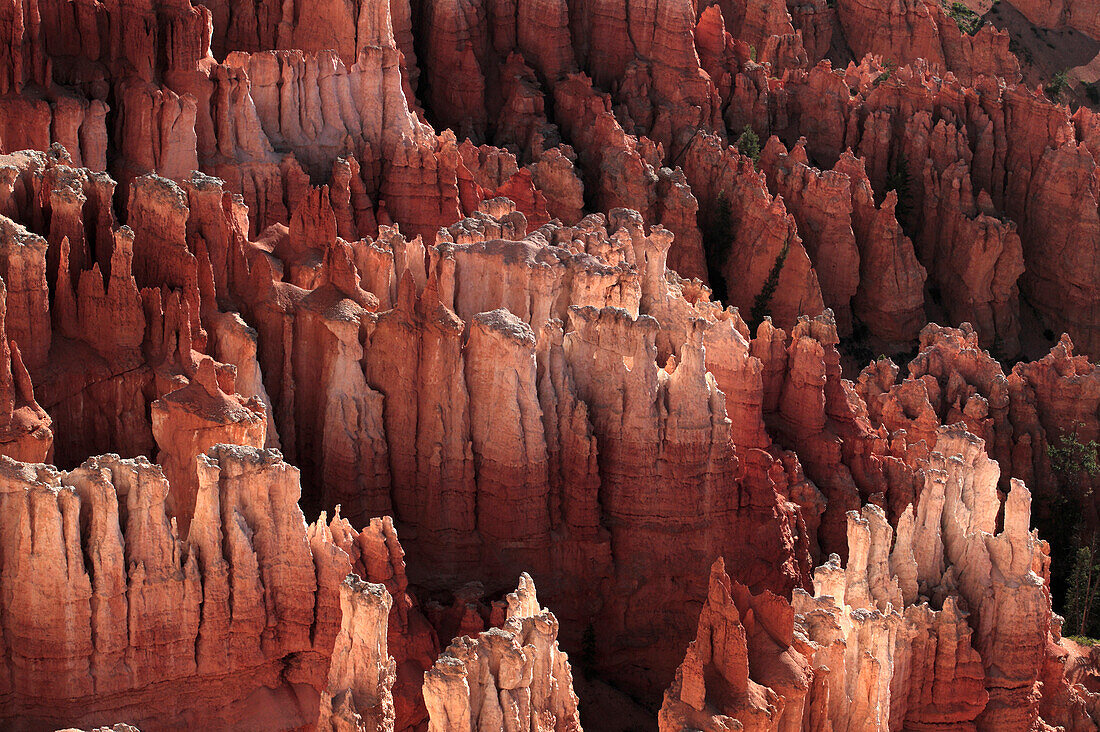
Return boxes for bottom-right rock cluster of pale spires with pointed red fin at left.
[660,426,1096,730]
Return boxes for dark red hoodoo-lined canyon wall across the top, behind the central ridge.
[0,0,1100,358]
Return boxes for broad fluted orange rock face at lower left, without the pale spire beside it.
[0,446,336,729]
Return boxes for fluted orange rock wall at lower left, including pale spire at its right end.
[0,445,435,732]
